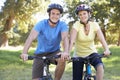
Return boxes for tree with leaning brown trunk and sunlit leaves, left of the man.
[0,0,49,47]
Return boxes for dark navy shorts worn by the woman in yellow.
[72,53,103,80]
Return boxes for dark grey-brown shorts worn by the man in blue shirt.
[32,50,60,79]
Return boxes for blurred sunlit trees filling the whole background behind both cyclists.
[0,0,120,47]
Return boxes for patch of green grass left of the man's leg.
[0,48,32,80]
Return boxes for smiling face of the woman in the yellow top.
[78,11,90,23]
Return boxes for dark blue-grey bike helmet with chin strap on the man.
[47,3,63,24]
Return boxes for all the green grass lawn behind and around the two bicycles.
[0,46,120,80]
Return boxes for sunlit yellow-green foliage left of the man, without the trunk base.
[0,0,50,45]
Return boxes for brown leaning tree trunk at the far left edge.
[0,16,14,47]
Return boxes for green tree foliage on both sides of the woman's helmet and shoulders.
[66,0,120,44]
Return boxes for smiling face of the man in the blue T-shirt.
[49,9,60,23]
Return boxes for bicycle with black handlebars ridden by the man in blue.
[28,55,60,80]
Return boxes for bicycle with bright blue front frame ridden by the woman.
[71,54,110,80]
